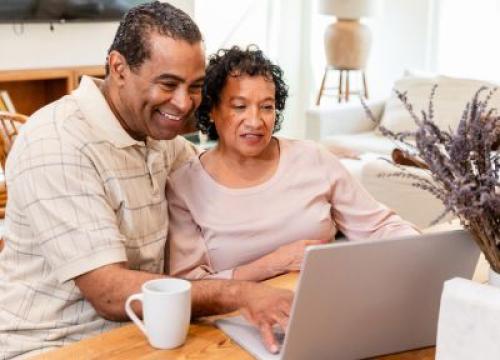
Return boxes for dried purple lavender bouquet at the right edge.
[362,85,500,273]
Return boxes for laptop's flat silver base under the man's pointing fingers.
[215,316,281,360]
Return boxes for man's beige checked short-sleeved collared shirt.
[0,77,196,359]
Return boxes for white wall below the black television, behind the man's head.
[0,0,194,70]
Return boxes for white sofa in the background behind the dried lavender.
[306,76,500,228]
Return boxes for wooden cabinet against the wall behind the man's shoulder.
[0,66,104,115]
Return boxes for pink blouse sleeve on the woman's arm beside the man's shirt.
[165,177,233,280]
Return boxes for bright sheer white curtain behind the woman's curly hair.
[194,0,314,137]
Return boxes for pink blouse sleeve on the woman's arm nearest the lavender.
[319,148,420,240]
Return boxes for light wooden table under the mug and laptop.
[37,273,435,360]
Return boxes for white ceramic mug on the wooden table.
[125,279,191,349]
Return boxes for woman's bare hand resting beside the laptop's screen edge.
[269,240,328,274]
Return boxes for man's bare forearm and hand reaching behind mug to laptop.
[75,263,293,352]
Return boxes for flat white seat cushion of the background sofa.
[321,131,397,156]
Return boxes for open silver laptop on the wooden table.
[216,230,480,360]
